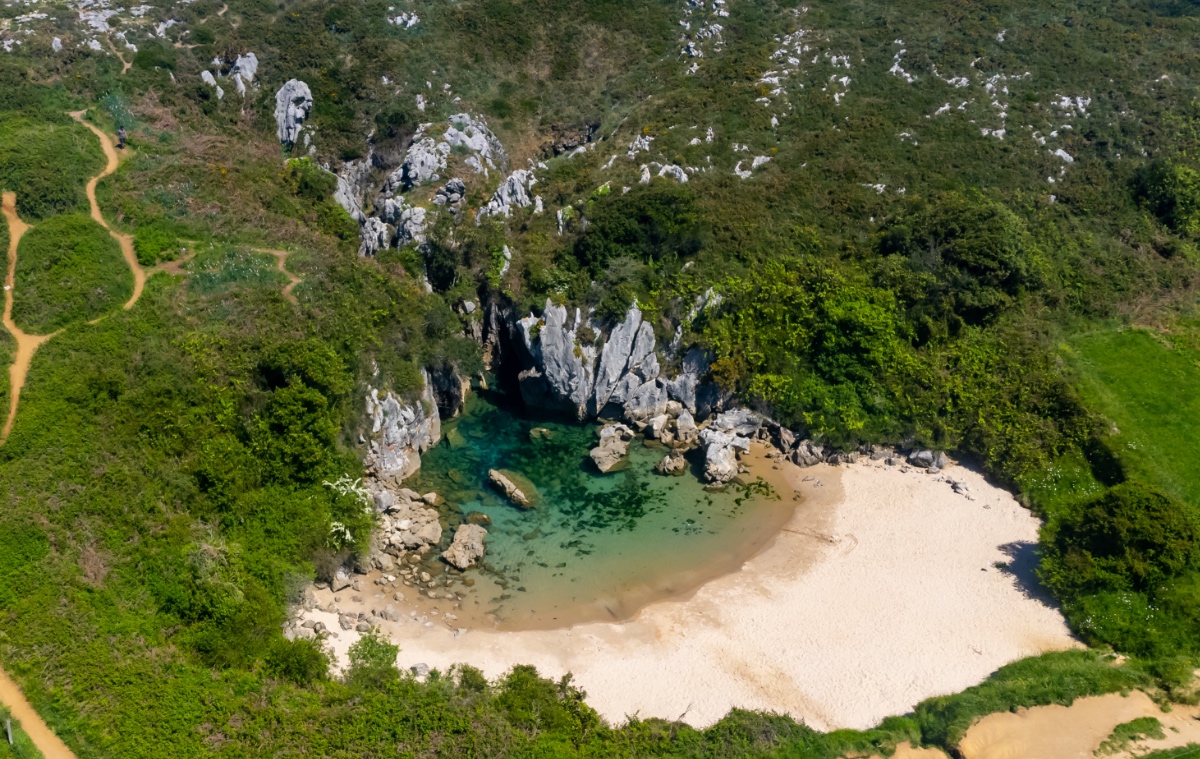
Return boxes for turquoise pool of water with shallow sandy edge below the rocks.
[410,394,794,629]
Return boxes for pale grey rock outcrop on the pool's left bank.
[367,371,442,483]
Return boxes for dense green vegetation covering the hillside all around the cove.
[0,0,1200,757]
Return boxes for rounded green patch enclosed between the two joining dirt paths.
[12,214,133,334]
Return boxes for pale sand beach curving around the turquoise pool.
[311,456,1078,730]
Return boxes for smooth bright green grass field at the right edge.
[1068,330,1200,504]
